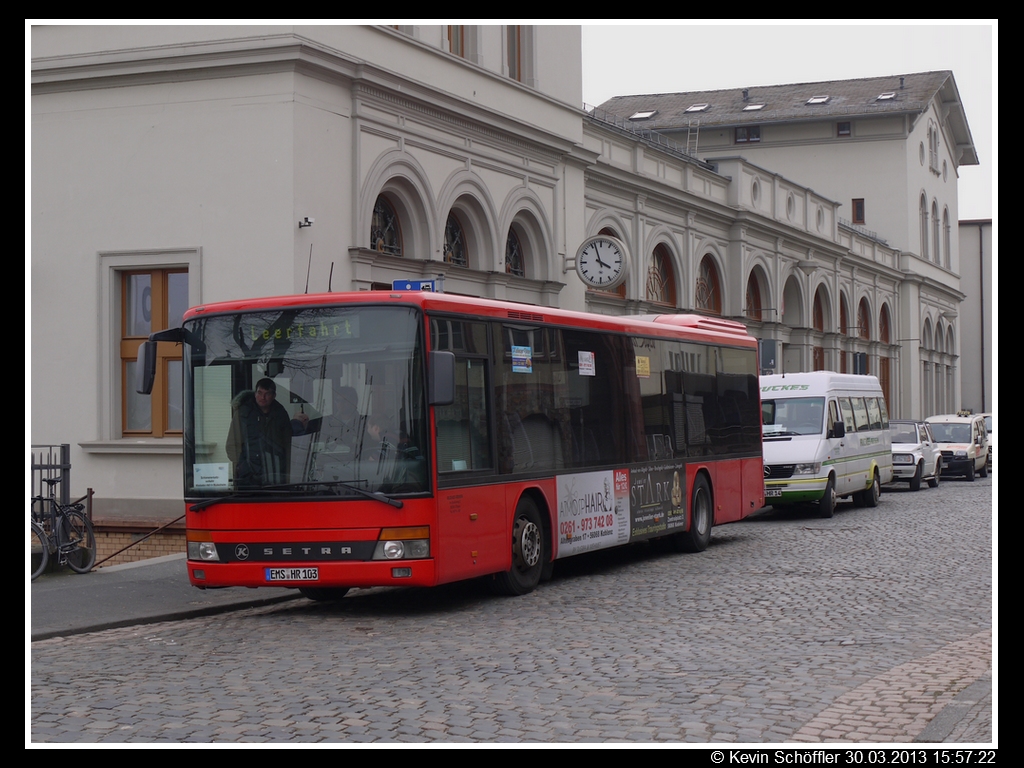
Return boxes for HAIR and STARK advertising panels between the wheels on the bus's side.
[555,462,686,558]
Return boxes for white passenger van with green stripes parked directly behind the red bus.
[761,371,893,517]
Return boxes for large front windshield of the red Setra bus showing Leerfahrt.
[184,305,429,499]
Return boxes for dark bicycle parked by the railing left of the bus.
[29,477,96,581]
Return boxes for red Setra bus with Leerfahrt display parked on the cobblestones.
[138,291,764,600]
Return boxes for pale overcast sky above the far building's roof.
[583,19,998,219]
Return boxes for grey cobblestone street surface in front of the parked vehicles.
[29,479,993,744]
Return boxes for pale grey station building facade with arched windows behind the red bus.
[31,26,974,516]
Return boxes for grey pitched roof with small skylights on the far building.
[598,71,978,165]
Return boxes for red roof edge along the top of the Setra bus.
[184,291,757,346]
